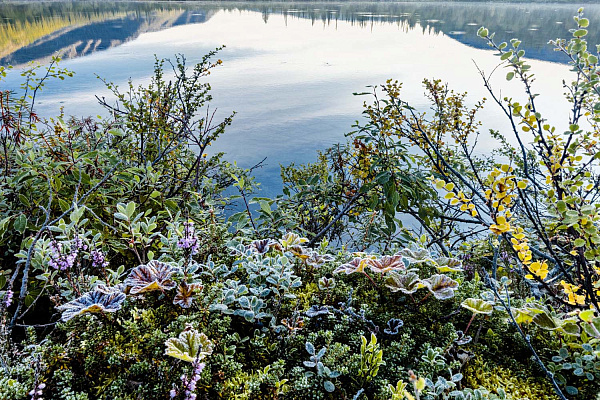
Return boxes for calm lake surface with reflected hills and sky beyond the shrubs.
[0,2,600,196]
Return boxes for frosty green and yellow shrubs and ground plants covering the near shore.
[0,10,600,400]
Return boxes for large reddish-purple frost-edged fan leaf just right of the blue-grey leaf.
[123,260,177,294]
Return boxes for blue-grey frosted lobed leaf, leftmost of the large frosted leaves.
[57,285,125,321]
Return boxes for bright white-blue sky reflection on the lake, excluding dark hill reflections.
[6,3,584,196]
